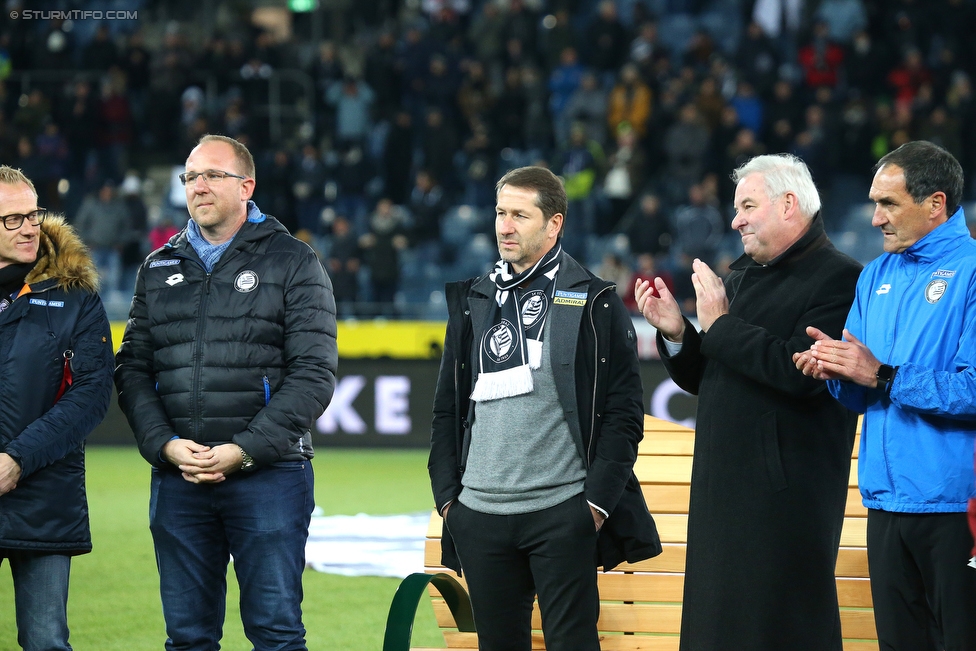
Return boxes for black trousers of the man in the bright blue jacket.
[868,509,976,651]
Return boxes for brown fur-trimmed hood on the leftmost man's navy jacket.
[25,215,98,292]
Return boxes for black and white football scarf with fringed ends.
[471,246,562,402]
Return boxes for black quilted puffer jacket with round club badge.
[115,211,338,468]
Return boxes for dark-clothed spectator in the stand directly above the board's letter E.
[359,198,409,316]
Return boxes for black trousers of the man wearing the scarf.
[447,493,600,651]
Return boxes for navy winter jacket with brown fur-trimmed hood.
[0,218,113,554]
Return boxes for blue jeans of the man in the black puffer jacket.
[149,461,314,651]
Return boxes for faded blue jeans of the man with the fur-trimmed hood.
[0,549,71,651]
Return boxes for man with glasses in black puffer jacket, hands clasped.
[115,135,338,651]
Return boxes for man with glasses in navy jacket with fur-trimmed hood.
[0,165,114,651]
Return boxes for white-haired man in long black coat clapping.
[635,154,861,651]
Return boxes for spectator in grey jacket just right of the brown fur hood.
[74,180,132,300]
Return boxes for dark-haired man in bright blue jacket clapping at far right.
[794,141,976,651]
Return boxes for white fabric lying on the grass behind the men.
[305,512,430,579]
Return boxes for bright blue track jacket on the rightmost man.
[828,208,976,513]
